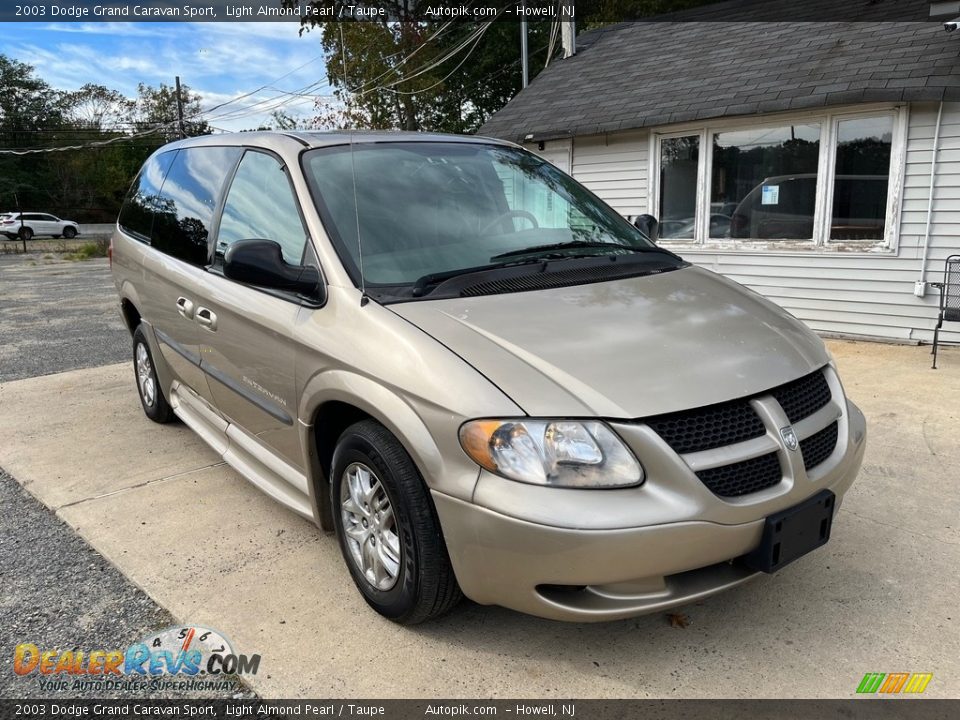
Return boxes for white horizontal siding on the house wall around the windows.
[560,102,960,342]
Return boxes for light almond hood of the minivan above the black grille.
[389,267,829,419]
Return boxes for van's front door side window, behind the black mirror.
[217,152,307,265]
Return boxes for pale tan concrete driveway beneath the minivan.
[0,341,960,698]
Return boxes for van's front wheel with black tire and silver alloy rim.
[330,420,462,625]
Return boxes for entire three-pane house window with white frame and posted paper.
[651,108,906,251]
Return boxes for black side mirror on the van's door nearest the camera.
[223,240,323,299]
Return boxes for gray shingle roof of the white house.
[479,17,960,141]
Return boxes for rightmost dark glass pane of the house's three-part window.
[830,115,893,240]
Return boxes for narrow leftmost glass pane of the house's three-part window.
[659,135,700,240]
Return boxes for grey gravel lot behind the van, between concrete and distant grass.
[0,253,131,382]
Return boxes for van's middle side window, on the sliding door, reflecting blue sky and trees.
[151,147,241,266]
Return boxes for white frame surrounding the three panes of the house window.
[647,103,909,256]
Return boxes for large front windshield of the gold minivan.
[304,142,679,287]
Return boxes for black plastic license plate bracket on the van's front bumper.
[743,490,836,573]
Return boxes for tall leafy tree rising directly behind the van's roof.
[284,0,556,133]
